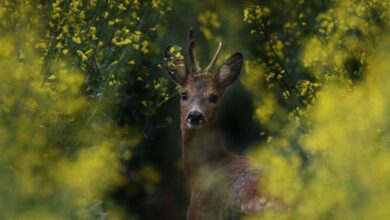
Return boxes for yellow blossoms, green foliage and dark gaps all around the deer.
[0,0,390,219]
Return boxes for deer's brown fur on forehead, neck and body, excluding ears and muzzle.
[180,76,280,219]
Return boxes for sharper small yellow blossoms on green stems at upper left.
[0,0,168,99]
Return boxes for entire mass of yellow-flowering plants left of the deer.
[0,0,168,219]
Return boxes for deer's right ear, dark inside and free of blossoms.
[216,52,243,87]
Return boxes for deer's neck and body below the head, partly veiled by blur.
[182,123,260,219]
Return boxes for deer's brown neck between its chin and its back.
[181,122,228,178]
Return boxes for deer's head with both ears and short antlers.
[165,29,243,129]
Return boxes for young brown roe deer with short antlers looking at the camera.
[165,29,279,220]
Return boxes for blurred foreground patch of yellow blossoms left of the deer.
[0,29,138,219]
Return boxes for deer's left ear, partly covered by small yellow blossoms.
[165,46,188,85]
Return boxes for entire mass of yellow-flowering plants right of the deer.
[242,0,390,219]
